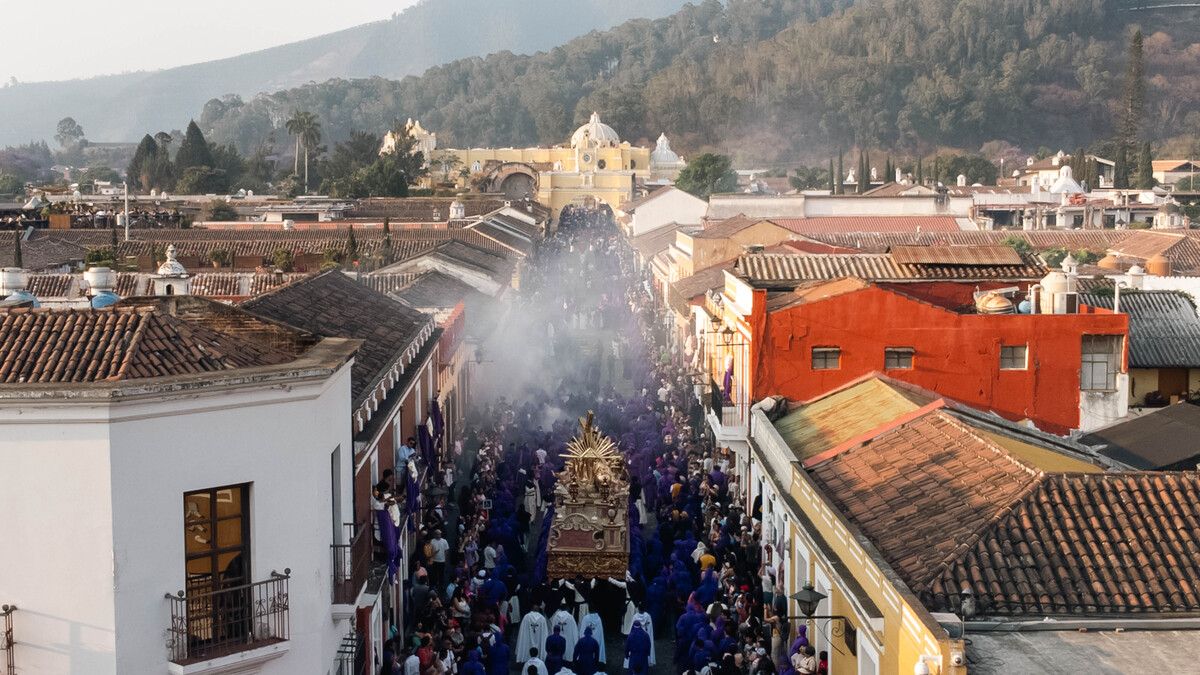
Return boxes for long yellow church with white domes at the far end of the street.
[403,113,685,214]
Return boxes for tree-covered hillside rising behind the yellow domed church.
[202,0,1200,162]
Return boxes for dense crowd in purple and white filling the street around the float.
[379,209,828,675]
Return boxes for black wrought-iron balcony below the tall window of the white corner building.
[167,569,292,675]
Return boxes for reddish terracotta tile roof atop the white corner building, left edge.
[0,307,294,384]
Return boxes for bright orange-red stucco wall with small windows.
[748,283,1128,432]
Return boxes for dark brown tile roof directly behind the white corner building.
[240,270,427,404]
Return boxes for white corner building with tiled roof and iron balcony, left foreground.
[0,297,359,675]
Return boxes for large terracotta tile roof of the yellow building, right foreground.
[810,398,1200,616]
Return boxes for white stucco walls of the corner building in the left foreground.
[0,365,352,675]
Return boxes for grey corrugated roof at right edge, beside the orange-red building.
[1079,291,1200,365]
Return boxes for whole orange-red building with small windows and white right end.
[704,249,1128,434]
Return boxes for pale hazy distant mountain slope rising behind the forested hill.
[0,0,684,145]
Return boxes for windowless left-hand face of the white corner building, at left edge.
[0,411,117,675]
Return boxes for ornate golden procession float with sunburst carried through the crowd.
[546,411,629,580]
